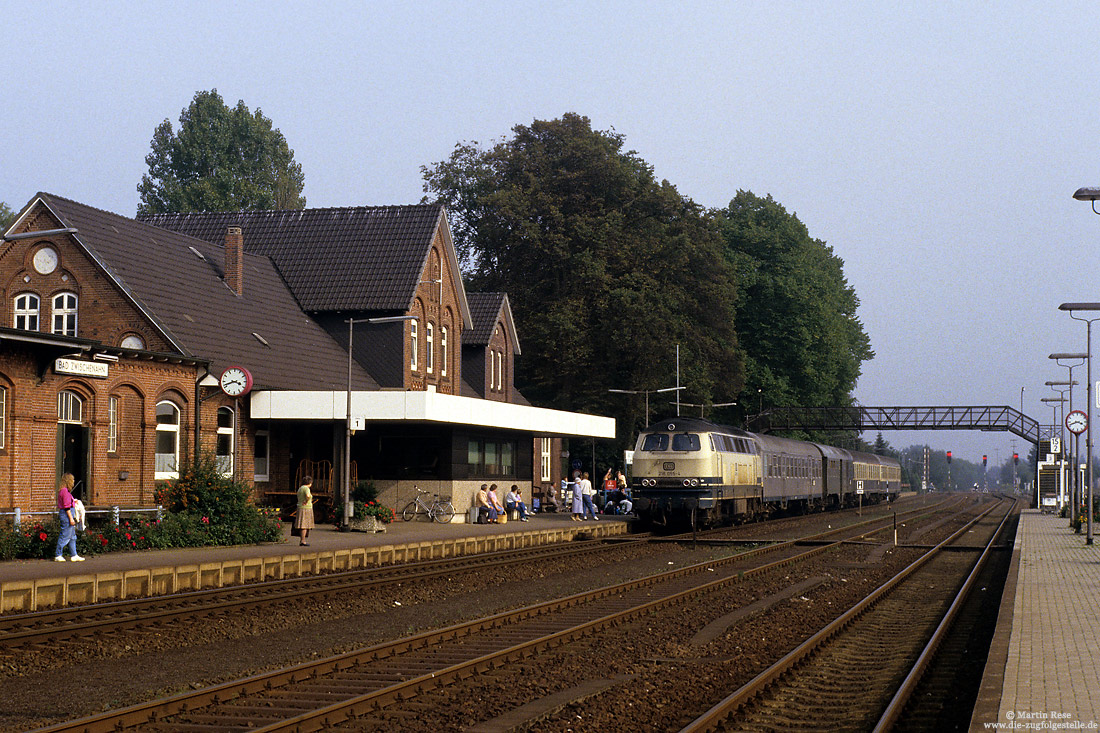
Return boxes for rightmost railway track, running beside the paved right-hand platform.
[681,493,1016,733]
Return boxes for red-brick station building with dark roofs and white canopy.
[0,193,615,513]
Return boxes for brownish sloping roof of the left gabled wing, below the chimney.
[36,193,377,390]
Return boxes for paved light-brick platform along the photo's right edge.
[970,510,1100,731]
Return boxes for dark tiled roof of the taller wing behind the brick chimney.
[146,204,444,311]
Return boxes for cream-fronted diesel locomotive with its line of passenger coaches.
[630,417,901,526]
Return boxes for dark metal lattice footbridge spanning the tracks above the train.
[748,405,1046,442]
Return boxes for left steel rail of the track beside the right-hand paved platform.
[680,500,1015,733]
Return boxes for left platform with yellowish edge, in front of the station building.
[0,513,631,613]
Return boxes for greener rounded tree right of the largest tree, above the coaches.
[718,190,875,407]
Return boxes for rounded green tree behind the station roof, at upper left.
[138,89,306,216]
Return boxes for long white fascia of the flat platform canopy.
[249,390,615,438]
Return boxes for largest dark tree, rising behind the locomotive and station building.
[424,113,741,439]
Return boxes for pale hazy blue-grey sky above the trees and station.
[0,0,1100,461]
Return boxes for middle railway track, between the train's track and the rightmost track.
[32,497,963,731]
